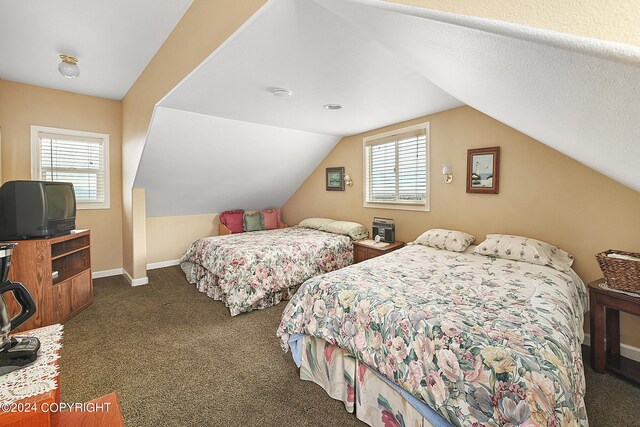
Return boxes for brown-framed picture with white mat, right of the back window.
[467,147,500,194]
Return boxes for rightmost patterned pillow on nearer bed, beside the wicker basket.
[474,234,573,272]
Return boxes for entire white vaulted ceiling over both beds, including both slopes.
[135,0,640,216]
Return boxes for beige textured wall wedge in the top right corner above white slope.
[387,0,640,46]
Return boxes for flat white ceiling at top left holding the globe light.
[0,0,192,99]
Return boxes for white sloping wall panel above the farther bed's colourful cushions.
[136,107,339,216]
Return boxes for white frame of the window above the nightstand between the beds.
[362,122,431,212]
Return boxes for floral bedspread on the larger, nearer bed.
[277,245,588,426]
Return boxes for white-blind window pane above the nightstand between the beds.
[364,124,428,210]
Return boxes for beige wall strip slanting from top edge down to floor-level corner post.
[122,0,265,279]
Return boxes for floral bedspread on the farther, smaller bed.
[180,227,353,316]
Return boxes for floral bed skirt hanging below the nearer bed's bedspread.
[292,335,451,427]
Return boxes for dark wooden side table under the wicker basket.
[588,279,640,382]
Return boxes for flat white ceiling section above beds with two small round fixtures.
[160,0,462,136]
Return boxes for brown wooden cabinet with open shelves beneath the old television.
[5,230,93,333]
